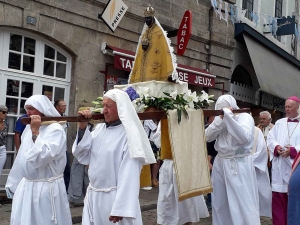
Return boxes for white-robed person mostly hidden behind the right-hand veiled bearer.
[251,127,272,218]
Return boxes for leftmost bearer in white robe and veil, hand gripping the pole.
[6,95,72,225]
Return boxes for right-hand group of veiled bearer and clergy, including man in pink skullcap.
[206,95,300,225]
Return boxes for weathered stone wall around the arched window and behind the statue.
[0,0,235,144]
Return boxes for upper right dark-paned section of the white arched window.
[44,45,67,79]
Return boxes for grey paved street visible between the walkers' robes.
[0,188,272,225]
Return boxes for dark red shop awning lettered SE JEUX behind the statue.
[105,45,216,88]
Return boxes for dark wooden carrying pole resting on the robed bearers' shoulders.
[21,107,250,124]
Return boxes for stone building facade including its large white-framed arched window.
[0,0,235,188]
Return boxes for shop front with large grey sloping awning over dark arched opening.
[230,23,300,122]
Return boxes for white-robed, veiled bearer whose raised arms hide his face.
[205,95,260,225]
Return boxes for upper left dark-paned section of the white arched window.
[8,34,36,73]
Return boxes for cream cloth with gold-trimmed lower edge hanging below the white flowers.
[168,109,212,201]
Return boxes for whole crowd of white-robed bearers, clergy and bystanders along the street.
[0,89,300,225]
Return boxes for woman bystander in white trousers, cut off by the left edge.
[0,105,8,207]
